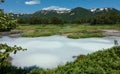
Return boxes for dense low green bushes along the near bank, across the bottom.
[0,45,120,74]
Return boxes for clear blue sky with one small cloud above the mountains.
[0,0,120,13]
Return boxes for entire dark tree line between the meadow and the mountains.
[18,12,120,25]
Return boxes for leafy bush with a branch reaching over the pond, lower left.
[0,44,26,74]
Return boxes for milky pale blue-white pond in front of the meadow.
[0,36,120,68]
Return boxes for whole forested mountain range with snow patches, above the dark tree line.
[13,6,120,20]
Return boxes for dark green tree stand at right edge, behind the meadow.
[90,11,120,24]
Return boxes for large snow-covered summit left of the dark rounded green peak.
[42,6,71,13]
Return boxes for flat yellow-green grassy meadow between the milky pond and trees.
[16,24,120,39]
